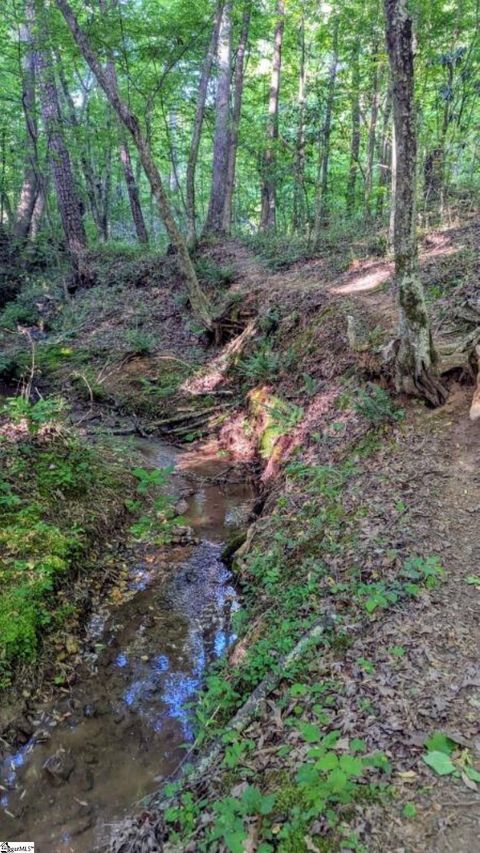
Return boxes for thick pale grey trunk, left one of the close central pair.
[204,0,232,234]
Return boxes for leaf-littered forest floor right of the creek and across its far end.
[0,221,480,853]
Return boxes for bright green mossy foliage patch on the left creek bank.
[0,397,129,687]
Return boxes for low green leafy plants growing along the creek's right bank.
[161,422,443,853]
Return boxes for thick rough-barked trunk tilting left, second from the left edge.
[35,0,87,264]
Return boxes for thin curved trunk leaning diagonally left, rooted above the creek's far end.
[56,0,212,329]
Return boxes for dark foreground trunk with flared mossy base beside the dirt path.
[384,0,446,406]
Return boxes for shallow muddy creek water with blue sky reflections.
[0,441,251,853]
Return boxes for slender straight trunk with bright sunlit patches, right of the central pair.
[260,0,285,231]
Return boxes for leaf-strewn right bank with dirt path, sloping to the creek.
[108,226,480,851]
